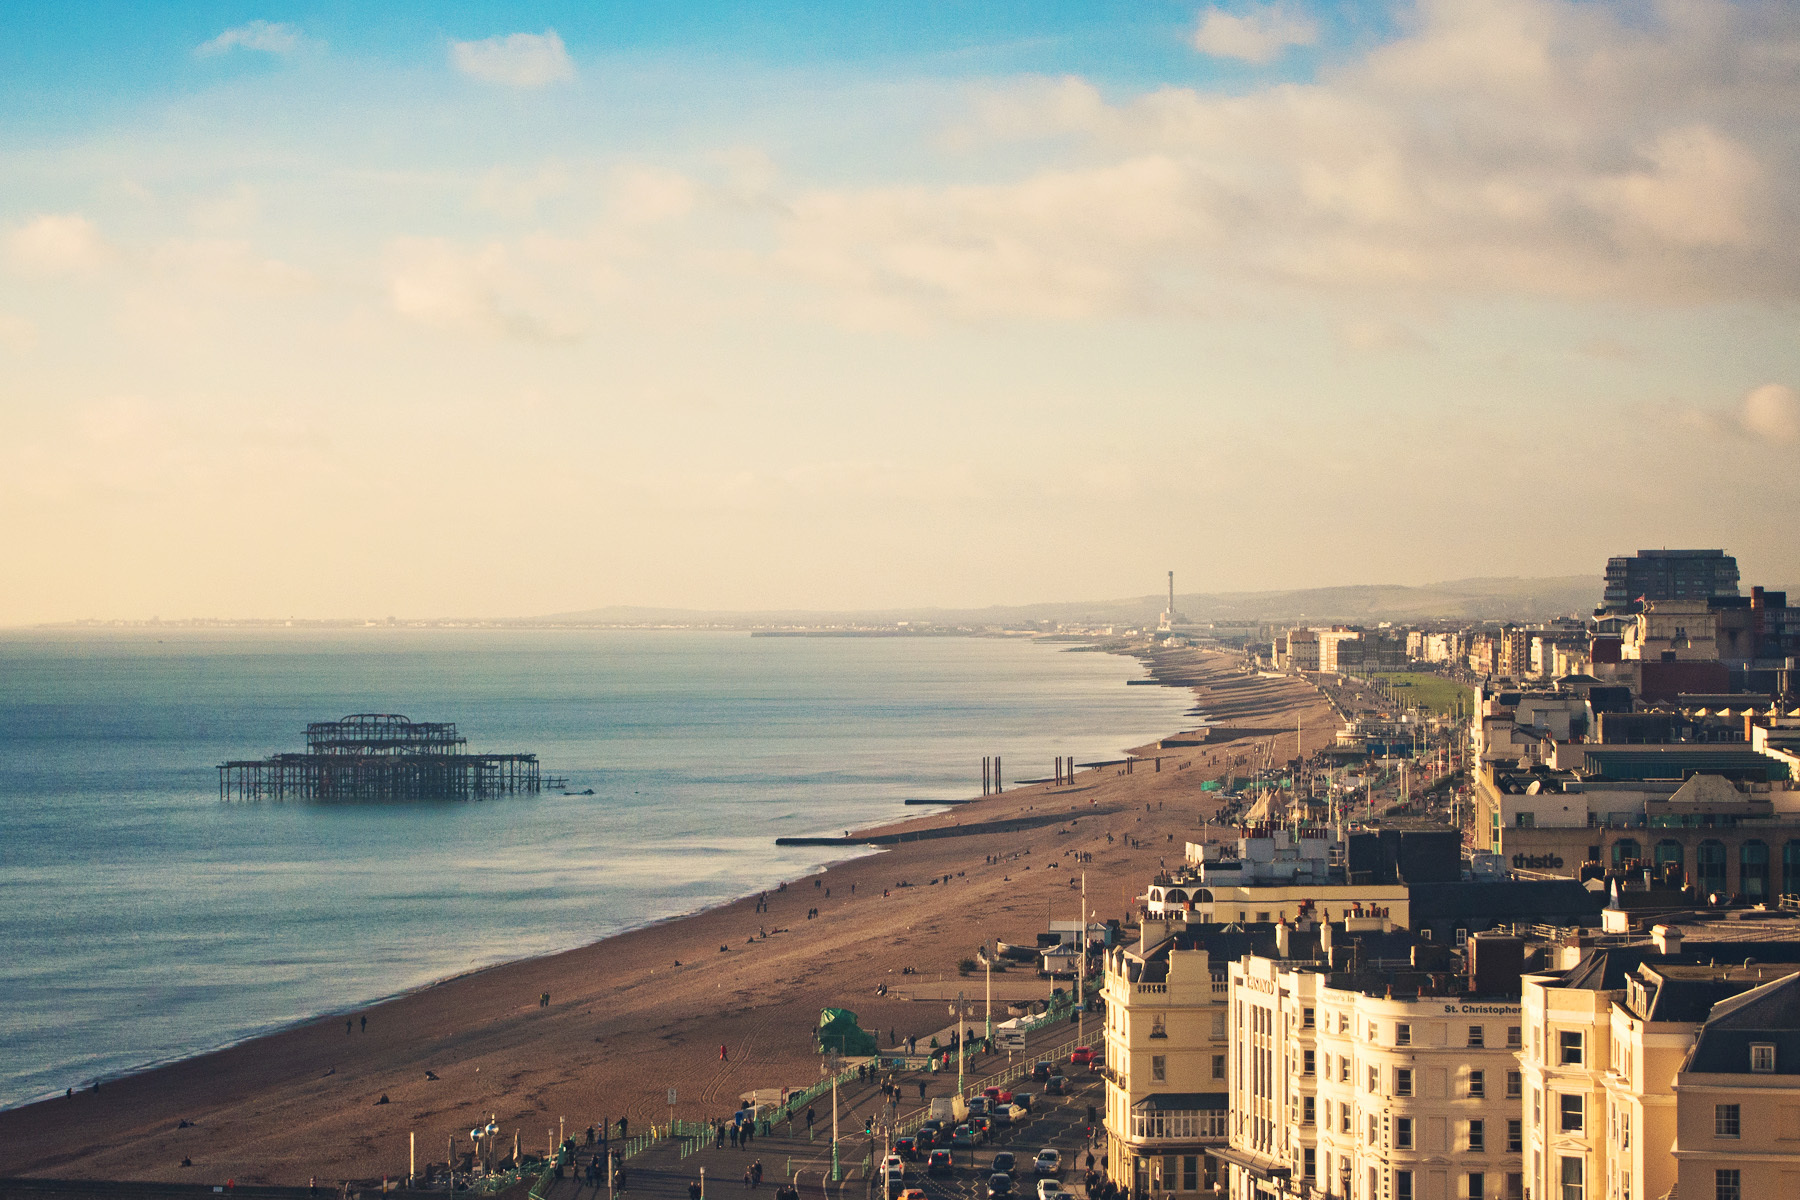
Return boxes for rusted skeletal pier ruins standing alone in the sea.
[220,712,545,801]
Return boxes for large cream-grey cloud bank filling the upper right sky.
[776,0,1800,318]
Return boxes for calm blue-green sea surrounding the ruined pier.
[0,628,1188,1105]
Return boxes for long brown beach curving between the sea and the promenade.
[0,651,1336,1184]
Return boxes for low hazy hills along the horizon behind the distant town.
[540,576,1600,626]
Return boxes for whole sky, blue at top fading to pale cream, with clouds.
[0,0,1800,624]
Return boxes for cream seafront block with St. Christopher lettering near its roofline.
[1224,939,1525,1200]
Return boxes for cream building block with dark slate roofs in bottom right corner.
[1519,919,1800,1200]
